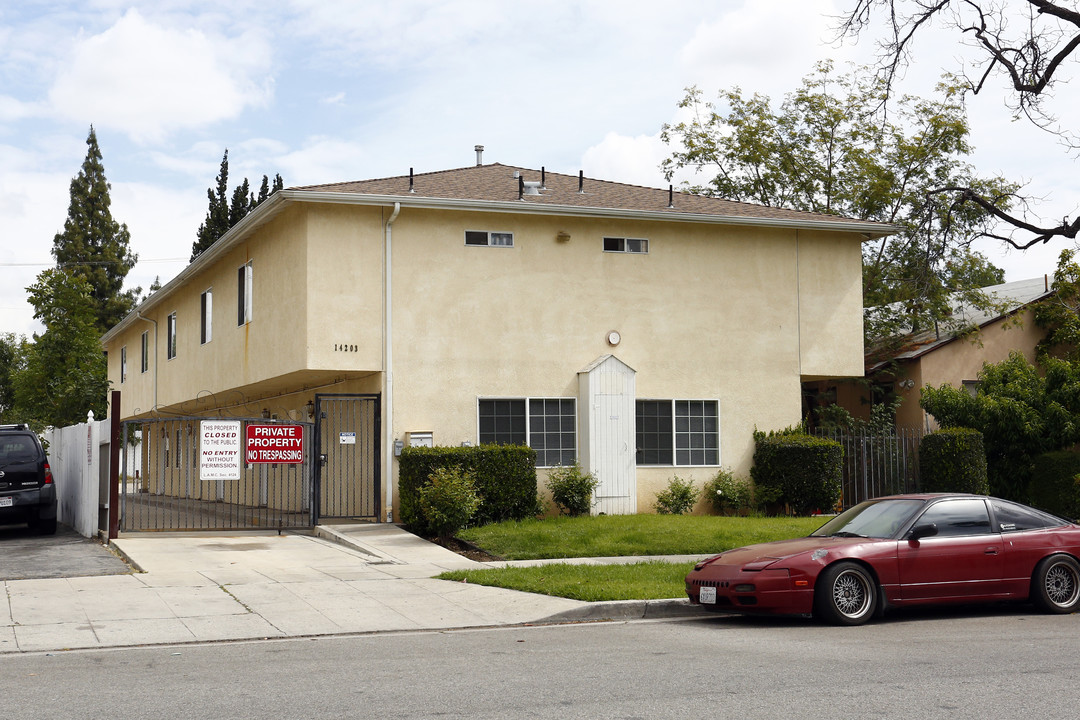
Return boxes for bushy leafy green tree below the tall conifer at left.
[13,268,109,427]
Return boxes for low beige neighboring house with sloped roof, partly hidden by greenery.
[810,275,1053,432]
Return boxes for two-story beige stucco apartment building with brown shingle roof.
[103,164,892,520]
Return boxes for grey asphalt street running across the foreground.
[4,607,1080,720]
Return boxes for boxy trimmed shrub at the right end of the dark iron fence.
[919,427,989,494]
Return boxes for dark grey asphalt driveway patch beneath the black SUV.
[0,525,132,581]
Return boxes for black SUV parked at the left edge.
[0,424,56,535]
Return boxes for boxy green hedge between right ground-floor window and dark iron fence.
[750,432,843,515]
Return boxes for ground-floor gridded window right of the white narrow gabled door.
[635,400,720,465]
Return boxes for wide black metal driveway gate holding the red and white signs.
[120,418,318,532]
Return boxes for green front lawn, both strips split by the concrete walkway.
[438,515,825,601]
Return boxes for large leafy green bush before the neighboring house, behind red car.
[919,351,1080,500]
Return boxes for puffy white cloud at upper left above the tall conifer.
[49,10,273,142]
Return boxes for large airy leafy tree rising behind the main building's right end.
[661,63,1015,339]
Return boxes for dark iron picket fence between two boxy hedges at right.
[816,429,922,508]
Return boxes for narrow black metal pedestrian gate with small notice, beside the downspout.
[315,394,382,520]
